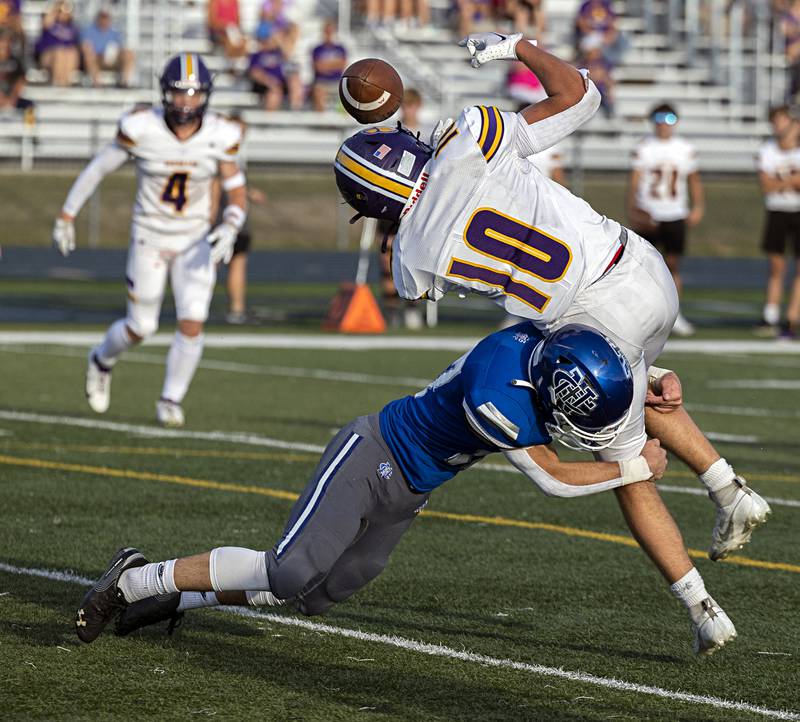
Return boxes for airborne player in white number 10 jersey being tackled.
[334,33,769,559]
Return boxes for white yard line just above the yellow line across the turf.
[0,409,800,507]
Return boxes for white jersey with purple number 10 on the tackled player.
[392,106,620,326]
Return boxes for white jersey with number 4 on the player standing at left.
[116,108,242,251]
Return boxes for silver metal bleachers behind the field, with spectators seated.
[0,0,783,172]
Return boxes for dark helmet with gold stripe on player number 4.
[160,53,214,125]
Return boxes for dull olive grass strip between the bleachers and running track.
[0,166,763,257]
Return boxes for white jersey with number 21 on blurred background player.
[633,136,697,223]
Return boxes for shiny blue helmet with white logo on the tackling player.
[529,324,633,451]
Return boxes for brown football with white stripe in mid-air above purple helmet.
[339,58,403,125]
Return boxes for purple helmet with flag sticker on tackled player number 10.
[333,123,433,221]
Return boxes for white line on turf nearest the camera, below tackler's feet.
[0,561,800,720]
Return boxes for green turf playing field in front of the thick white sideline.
[0,326,800,721]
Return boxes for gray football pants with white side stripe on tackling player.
[266,415,429,615]
